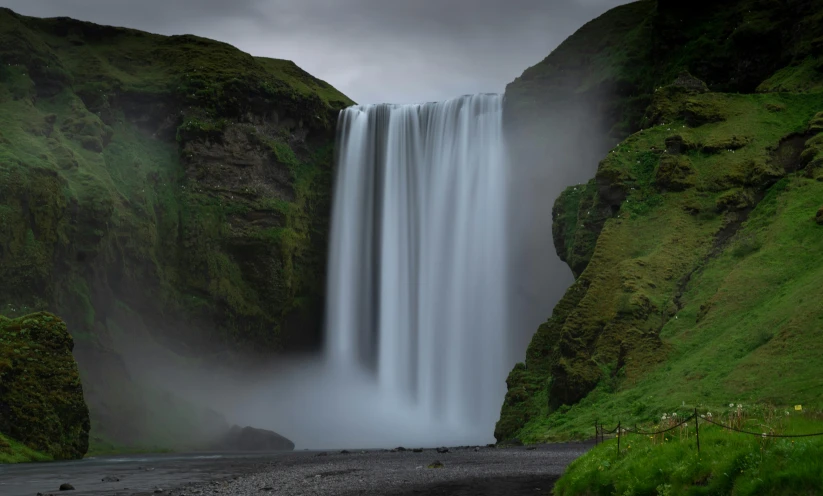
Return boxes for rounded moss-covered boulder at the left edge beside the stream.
[0,312,90,460]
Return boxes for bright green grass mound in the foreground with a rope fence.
[554,405,823,496]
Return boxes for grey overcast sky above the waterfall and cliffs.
[0,0,628,103]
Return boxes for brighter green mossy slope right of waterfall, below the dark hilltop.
[495,89,823,442]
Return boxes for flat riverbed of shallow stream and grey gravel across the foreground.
[6,443,591,496]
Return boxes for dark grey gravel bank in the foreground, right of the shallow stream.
[125,444,588,496]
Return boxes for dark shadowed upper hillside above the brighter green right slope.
[506,0,823,140]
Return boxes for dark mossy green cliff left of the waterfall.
[0,9,352,450]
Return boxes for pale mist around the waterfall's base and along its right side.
[96,91,606,449]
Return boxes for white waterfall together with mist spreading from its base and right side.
[124,95,602,449]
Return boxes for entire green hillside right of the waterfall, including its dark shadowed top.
[495,0,823,441]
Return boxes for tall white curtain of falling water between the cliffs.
[326,95,510,442]
